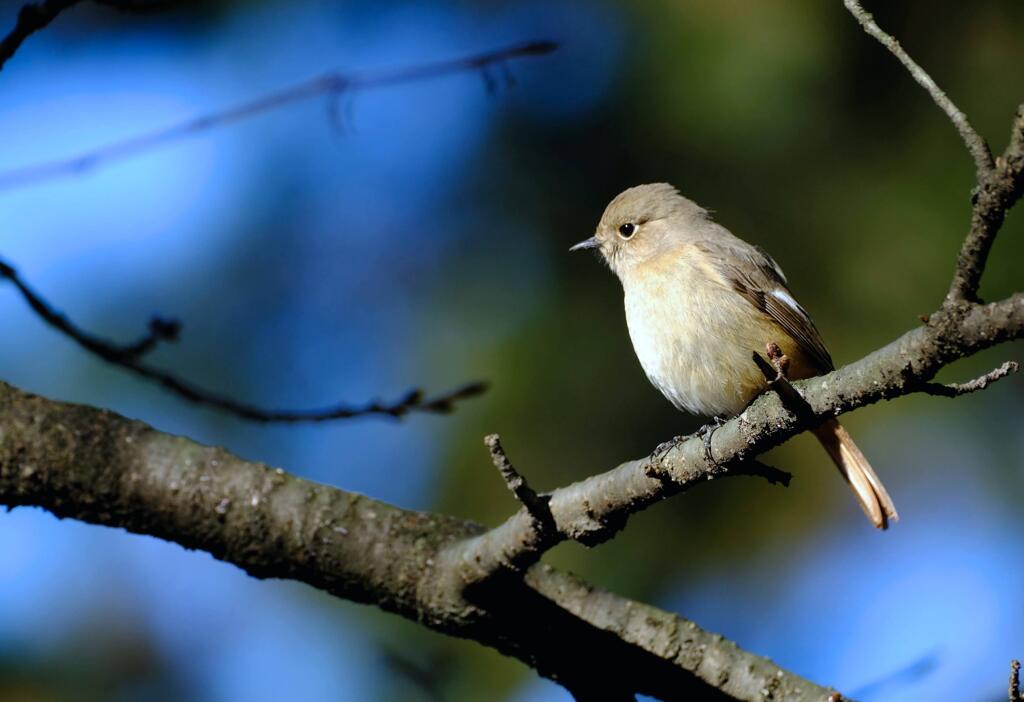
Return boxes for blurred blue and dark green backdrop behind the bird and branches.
[0,0,1024,702]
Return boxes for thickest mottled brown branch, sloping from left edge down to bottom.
[0,383,829,701]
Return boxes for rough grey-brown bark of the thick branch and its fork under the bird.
[0,294,1024,700]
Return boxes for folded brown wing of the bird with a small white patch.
[704,238,834,372]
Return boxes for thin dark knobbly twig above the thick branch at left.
[0,261,486,424]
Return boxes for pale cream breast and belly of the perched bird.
[622,253,781,416]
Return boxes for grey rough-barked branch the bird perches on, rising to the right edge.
[457,293,1024,583]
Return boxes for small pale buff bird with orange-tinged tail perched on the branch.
[569,183,899,529]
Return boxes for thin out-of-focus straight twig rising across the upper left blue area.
[0,41,557,189]
